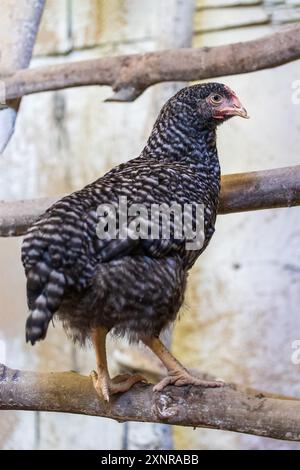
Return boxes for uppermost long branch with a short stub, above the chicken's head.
[4,23,300,101]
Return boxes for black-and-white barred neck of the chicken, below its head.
[142,117,220,176]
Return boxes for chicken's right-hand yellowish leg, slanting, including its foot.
[143,338,224,391]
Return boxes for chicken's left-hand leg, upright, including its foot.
[91,327,145,401]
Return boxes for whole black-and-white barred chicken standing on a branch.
[22,83,248,401]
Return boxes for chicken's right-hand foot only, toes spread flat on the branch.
[153,369,225,392]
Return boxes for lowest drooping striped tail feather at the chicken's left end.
[26,294,52,345]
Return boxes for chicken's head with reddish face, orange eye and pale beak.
[167,83,248,127]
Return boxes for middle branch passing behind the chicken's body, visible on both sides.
[0,165,300,237]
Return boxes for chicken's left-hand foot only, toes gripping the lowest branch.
[91,371,147,401]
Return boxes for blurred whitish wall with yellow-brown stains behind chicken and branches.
[0,0,300,449]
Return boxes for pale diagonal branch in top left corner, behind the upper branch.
[0,0,45,154]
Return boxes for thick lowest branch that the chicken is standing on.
[0,365,300,441]
